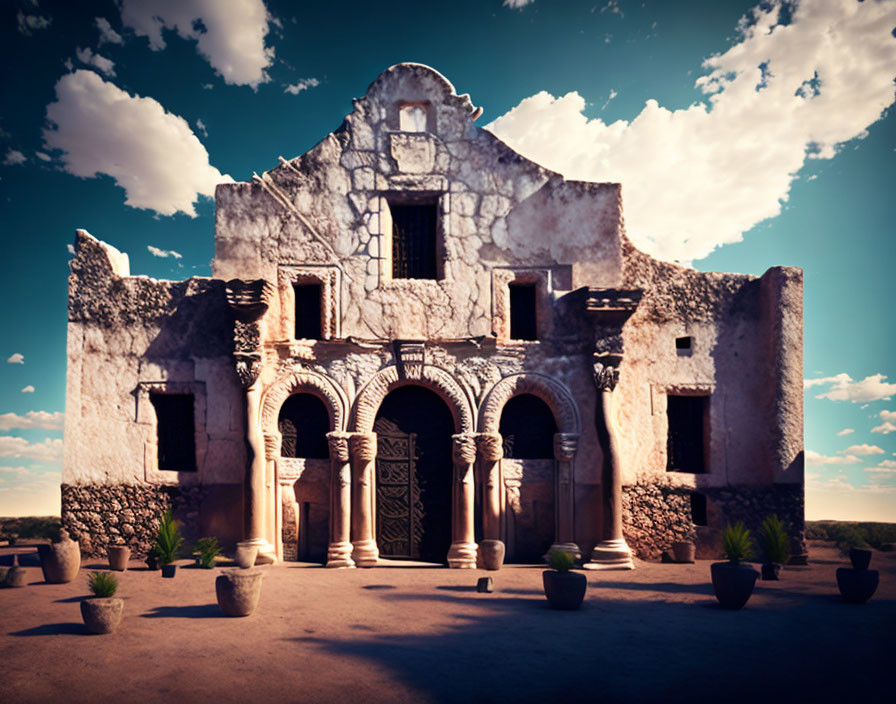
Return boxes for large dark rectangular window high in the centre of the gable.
[389,202,438,279]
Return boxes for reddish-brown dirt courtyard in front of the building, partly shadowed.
[0,543,896,704]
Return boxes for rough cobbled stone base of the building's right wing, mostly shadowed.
[622,484,806,560]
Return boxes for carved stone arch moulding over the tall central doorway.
[352,365,475,433]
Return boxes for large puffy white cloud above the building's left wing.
[44,70,233,217]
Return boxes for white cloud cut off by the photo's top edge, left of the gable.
[121,0,274,88]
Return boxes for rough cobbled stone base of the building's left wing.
[62,484,203,557]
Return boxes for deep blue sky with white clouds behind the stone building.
[0,0,896,521]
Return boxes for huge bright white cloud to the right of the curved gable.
[488,0,896,261]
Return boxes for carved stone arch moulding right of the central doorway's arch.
[479,372,580,435]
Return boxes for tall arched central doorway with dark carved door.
[373,385,454,562]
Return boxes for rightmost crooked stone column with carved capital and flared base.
[585,357,635,570]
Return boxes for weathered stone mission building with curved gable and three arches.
[62,64,803,567]
